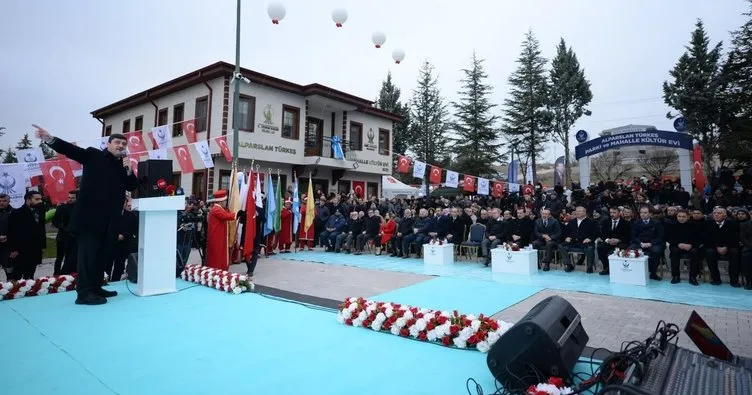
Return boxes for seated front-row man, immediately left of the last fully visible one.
[666,209,702,285]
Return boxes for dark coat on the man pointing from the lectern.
[49,138,138,235]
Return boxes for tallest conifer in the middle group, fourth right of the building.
[504,30,551,183]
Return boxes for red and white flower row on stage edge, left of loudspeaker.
[337,298,512,353]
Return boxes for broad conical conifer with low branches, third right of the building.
[452,52,503,177]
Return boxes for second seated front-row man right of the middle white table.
[559,206,598,273]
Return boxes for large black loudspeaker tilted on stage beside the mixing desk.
[486,296,589,391]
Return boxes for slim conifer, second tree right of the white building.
[408,61,449,166]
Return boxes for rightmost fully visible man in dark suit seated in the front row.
[703,207,740,288]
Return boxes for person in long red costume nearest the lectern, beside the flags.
[206,189,245,270]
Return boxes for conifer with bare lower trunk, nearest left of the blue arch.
[548,38,593,185]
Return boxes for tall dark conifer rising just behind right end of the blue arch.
[663,20,727,169]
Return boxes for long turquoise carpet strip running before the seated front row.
[276,251,752,310]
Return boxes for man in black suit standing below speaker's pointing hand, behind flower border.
[8,191,47,280]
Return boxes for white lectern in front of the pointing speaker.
[132,196,185,296]
